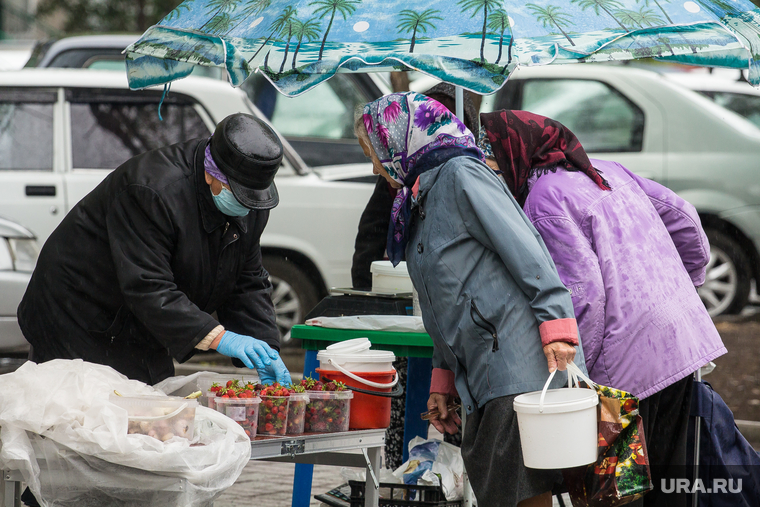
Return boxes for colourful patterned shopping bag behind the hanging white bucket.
[563,365,652,507]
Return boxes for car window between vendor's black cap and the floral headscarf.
[243,73,367,139]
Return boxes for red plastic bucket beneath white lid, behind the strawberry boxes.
[317,368,396,430]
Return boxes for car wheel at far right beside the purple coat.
[699,229,752,317]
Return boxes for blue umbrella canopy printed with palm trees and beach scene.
[127,0,760,96]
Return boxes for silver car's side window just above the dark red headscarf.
[497,79,644,152]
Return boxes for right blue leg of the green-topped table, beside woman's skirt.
[402,357,433,462]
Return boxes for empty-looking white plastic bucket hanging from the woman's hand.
[514,363,599,469]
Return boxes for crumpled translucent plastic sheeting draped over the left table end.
[0,359,251,507]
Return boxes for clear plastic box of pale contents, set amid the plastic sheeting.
[109,394,198,442]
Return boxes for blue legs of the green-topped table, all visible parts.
[291,347,432,507]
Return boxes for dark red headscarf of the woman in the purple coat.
[480,110,610,204]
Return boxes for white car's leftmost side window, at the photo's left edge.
[0,88,56,171]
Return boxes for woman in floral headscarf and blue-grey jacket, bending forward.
[356,93,584,507]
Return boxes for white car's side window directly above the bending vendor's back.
[67,90,211,169]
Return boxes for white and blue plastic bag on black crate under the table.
[393,437,464,501]
